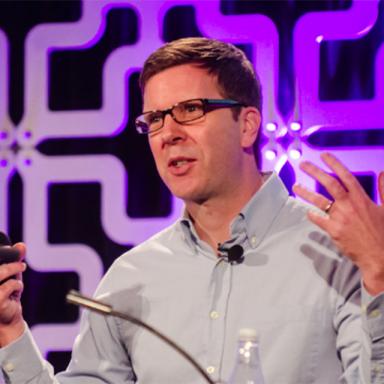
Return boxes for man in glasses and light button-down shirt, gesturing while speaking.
[0,38,384,384]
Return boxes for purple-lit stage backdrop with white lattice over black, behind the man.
[0,0,384,369]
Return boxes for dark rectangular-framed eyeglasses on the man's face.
[135,99,245,134]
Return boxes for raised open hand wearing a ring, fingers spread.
[293,153,384,295]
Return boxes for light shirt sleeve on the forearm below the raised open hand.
[333,258,384,384]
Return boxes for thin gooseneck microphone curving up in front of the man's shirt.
[66,290,219,384]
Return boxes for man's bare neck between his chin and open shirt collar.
[185,172,262,251]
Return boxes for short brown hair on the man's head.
[139,37,262,166]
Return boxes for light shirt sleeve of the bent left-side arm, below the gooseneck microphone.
[0,311,136,384]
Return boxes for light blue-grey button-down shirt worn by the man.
[0,175,384,384]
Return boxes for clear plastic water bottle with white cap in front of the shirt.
[228,328,265,384]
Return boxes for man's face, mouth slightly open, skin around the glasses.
[143,64,256,203]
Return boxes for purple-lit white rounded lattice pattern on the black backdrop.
[0,0,384,353]
